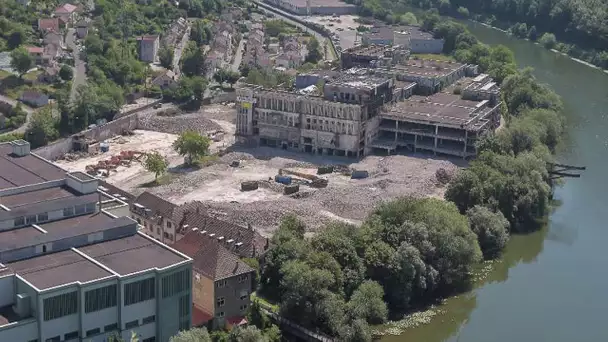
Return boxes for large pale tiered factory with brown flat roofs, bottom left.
[0,140,192,342]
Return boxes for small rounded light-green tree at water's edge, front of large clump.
[348,280,388,324]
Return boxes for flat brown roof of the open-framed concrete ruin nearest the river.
[386,93,484,124]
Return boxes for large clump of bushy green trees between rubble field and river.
[260,198,481,341]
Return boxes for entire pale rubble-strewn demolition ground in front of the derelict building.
[57,105,457,235]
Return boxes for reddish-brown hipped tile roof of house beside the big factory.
[172,230,254,281]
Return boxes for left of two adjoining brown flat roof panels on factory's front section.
[7,250,113,290]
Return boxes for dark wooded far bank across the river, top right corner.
[347,0,608,68]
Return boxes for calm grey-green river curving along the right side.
[382,23,608,342]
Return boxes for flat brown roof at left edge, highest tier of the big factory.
[0,143,65,190]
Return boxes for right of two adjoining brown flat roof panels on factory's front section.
[78,233,187,276]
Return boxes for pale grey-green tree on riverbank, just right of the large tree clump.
[467,206,509,259]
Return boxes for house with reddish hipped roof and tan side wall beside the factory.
[172,227,255,329]
